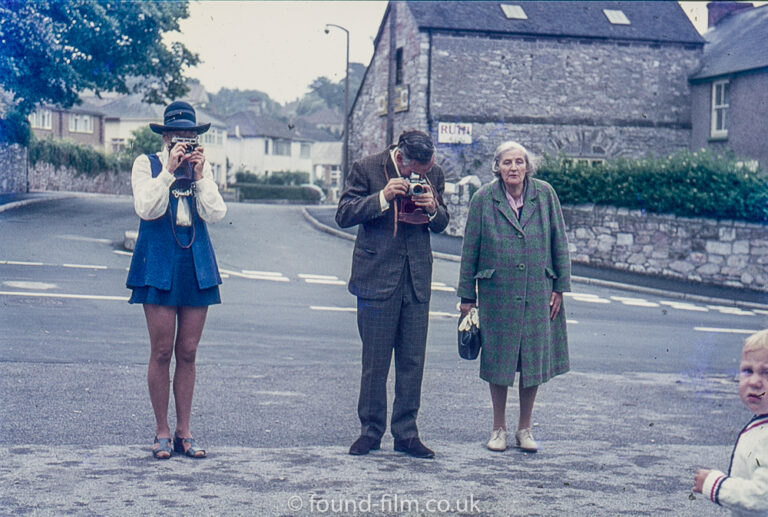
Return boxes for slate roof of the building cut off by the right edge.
[691,5,768,81]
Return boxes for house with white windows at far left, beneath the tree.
[29,101,104,148]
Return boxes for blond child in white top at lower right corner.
[693,329,768,515]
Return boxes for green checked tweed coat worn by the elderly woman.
[457,178,571,388]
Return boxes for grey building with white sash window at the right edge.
[690,2,768,169]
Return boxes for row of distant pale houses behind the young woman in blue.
[29,85,342,195]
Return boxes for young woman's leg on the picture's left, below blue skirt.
[144,304,176,450]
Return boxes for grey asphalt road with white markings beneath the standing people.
[0,196,766,515]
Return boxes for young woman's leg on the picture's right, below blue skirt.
[173,307,208,438]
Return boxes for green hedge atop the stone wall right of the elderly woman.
[537,150,768,222]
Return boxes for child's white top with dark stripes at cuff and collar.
[702,415,768,515]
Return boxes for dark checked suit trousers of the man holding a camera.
[357,262,429,440]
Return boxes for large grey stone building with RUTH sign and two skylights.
[350,1,704,181]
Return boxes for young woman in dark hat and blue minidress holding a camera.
[126,101,227,459]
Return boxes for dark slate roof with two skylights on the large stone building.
[404,0,704,44]
